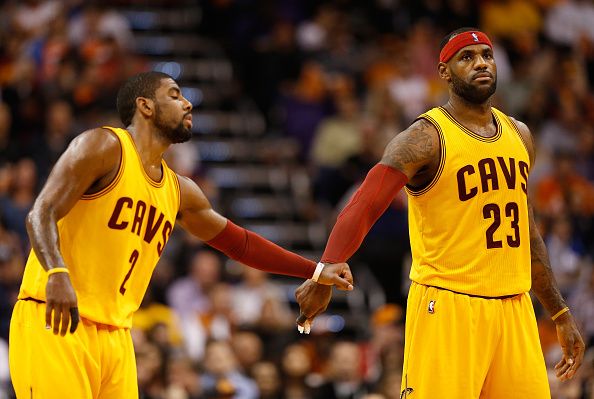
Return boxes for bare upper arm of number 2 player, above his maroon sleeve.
[178,176,227,241]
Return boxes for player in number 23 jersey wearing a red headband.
[297,28,584,399]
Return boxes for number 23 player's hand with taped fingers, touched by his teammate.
[295,280,332,334]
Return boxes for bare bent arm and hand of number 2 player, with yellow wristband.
[26,129,121,336]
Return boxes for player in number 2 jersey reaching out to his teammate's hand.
[9,72,352,399]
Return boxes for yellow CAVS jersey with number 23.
[406,107,531,297]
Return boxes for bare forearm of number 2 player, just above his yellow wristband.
[26,203,66,270]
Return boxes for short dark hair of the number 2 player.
[117,71,173,126]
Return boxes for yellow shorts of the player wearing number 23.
[401,282,551,399]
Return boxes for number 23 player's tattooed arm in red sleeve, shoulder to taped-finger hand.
[295,119,440,327]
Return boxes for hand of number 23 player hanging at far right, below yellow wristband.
[555,312,585,381]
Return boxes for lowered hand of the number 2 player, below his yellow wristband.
[45,273,79,336]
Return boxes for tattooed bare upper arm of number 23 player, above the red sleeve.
[381,119,440,179]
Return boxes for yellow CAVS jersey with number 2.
[19,128,180,328]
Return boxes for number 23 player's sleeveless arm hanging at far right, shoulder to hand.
[514,119,585,381]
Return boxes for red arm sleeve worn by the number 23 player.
[322,164,408,263]
